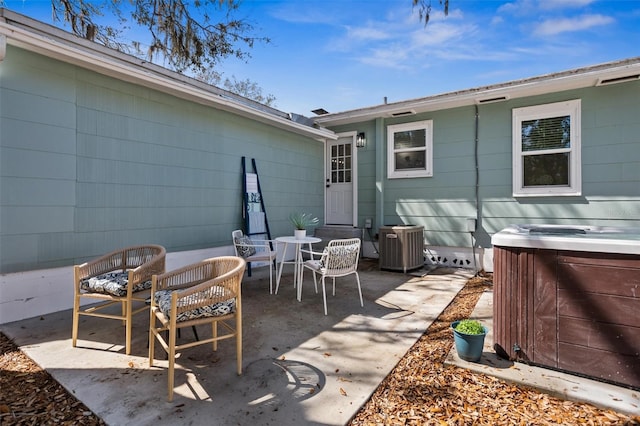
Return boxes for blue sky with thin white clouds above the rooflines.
[5,0,640,116]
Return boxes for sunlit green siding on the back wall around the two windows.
[332,82,640,247]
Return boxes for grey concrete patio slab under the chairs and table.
[0,262,473,426]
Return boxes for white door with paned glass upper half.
[326,134,356,226]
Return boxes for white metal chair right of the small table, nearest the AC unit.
[300,238,364,315]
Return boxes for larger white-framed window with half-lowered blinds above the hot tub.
[513,99,582,197]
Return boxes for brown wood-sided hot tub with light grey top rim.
[492,225,640,389]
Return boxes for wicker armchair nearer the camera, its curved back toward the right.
[149,256,246,401]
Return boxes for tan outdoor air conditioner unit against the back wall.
[378,225,424,273]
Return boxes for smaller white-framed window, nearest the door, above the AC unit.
[387,120,433,179]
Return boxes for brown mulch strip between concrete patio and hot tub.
[350,275,640,426]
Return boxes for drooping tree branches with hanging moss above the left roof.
[51,0,269,71]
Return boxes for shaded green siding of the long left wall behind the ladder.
[0,46,324,273]
